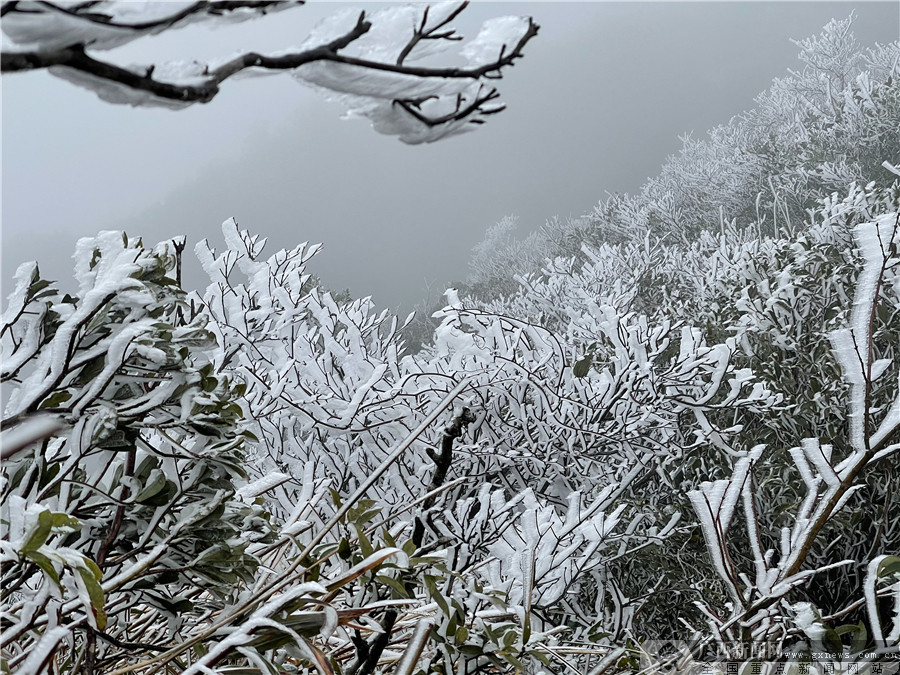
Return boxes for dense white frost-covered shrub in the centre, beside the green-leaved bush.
[185,210,766,668]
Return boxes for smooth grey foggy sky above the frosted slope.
[2,1,900,309]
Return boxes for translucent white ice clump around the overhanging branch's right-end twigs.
[294,2,535,143]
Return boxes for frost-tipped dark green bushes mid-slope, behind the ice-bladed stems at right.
[460,176,900,660]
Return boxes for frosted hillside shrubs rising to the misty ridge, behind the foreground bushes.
[458,20,900,660]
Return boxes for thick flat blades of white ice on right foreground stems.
[689,194,900,651]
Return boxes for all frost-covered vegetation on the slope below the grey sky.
[0,5,900,675]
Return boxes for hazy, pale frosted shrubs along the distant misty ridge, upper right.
[472,16,900,300]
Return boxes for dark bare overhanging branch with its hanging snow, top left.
[2,1,538,144]
